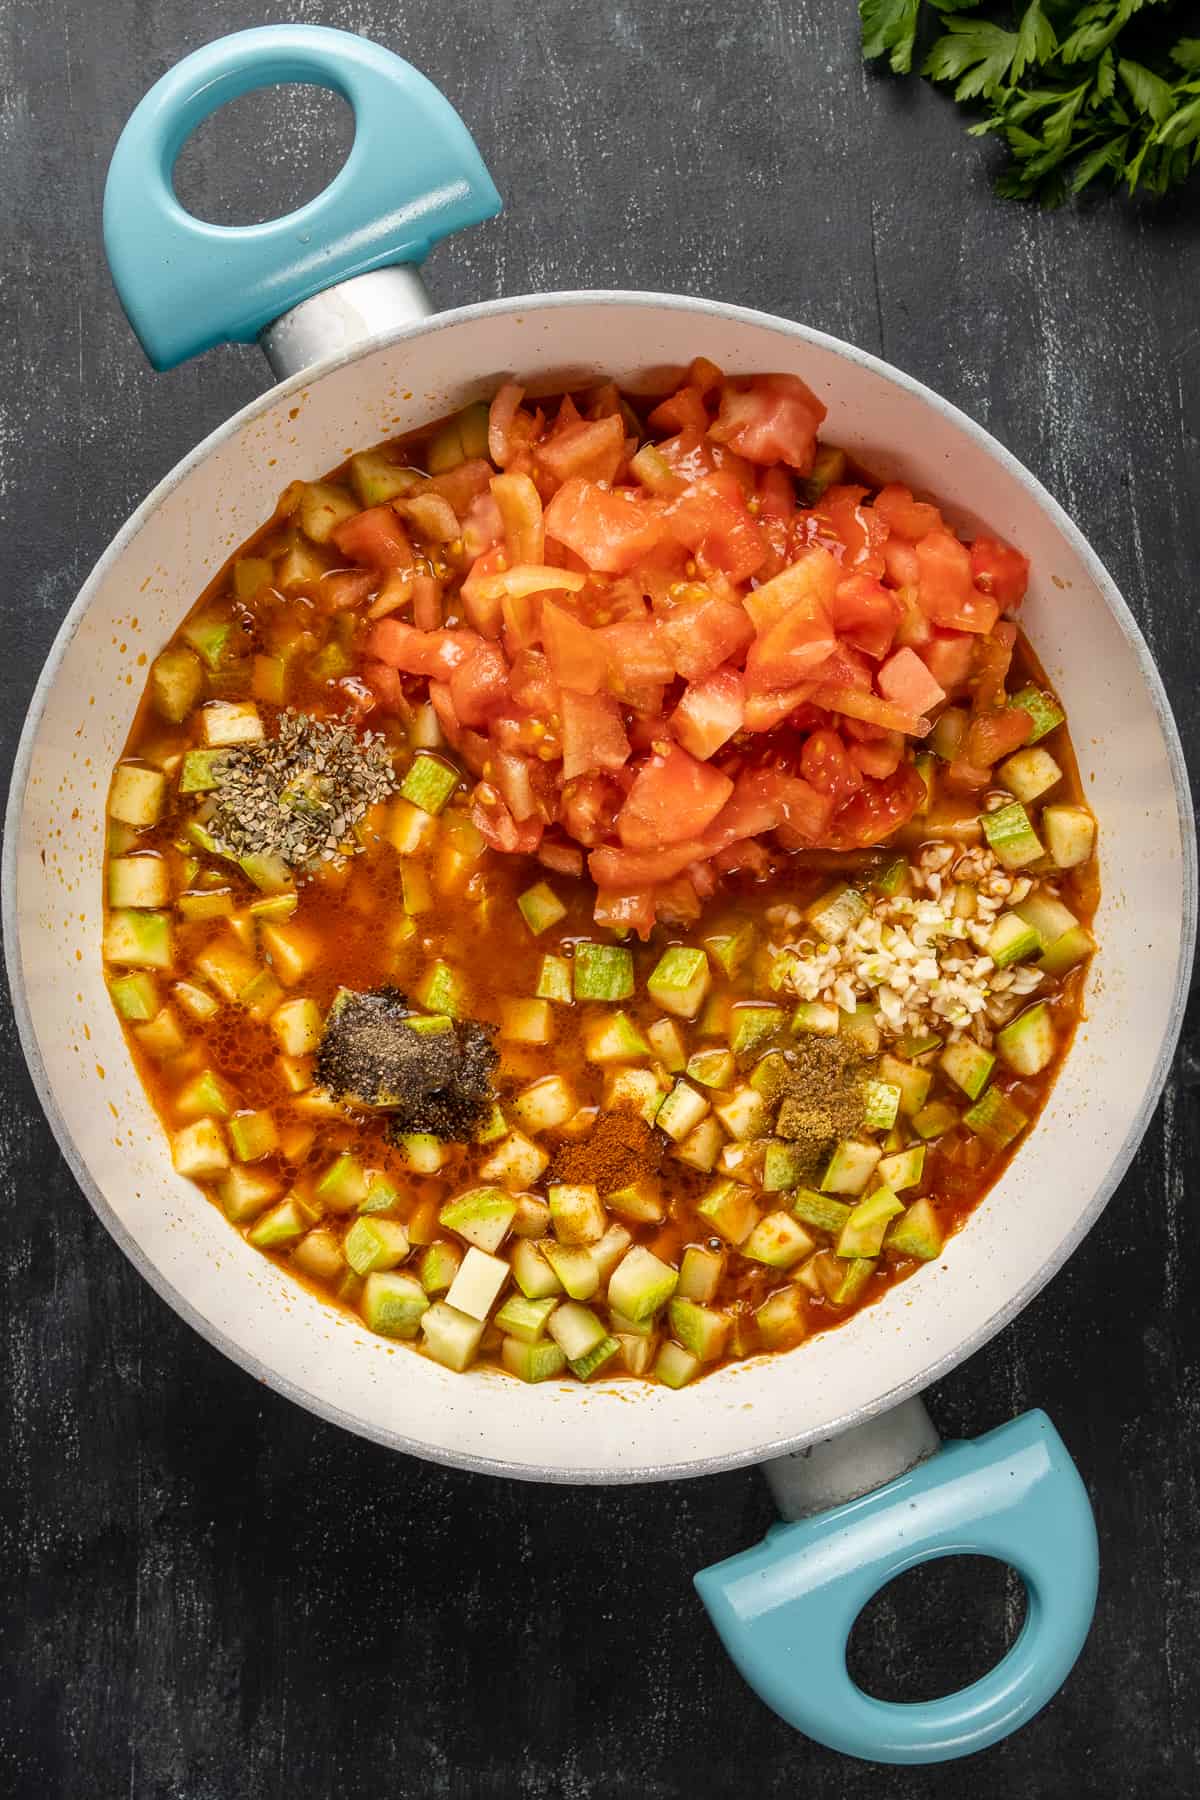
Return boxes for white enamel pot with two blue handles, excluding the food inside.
[4,27,1196,1762]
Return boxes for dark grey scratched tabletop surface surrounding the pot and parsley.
[0,0,1200,1800]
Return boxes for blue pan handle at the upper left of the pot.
[104,25,500,369]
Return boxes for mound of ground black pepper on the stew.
[317,988,498,1141]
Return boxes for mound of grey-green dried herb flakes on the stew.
[207,711,396,869]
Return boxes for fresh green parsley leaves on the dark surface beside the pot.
[858,0,1200,205]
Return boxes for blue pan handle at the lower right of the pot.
[696,1411,1099,1762]
